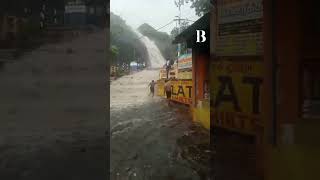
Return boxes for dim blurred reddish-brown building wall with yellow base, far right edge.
[264,0,320,180]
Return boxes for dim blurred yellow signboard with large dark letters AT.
[211,62,263,134]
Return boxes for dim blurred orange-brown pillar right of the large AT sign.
[276,0,302,144]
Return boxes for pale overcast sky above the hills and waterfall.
[110,0,199,33]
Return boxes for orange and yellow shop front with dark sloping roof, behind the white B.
[173,13,210,130]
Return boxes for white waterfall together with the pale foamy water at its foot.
[110,32,165,111]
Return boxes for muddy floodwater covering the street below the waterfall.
[110,70,210,180]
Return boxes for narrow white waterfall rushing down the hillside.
[135,31,166,68]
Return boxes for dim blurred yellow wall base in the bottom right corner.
[266,119,320,180]
